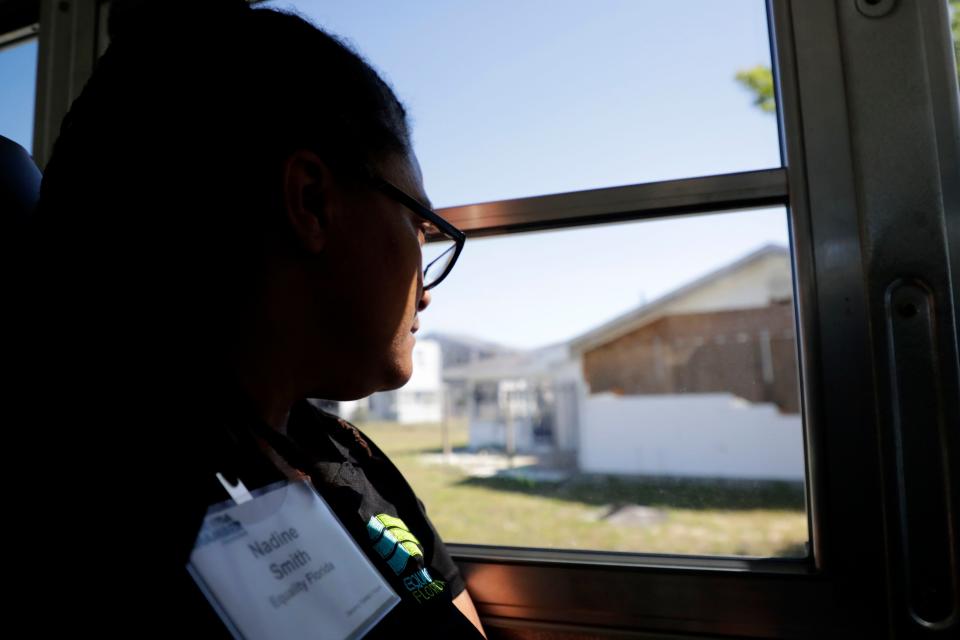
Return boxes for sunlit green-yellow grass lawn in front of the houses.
[358,422,807,556]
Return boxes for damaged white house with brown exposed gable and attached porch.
[444,245,804,480]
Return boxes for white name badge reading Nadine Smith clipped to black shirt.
[187,481,400,640]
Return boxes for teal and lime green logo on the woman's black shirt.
[367,513,446,603]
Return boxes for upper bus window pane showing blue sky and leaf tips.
[267,0,780,207]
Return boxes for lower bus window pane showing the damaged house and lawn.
[337,208,808,556]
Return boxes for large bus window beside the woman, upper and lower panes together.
[267,1,808,557]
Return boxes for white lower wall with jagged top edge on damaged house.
[578,393,804,480]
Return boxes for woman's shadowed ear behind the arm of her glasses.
[283,149,333,253]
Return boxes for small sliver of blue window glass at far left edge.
[0,38,37,151]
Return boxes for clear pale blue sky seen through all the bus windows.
[0,0,787,347]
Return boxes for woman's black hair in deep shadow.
[32,0,409,360]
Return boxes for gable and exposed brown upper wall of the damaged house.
[570,246,800,413]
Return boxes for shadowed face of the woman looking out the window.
[316,154,430,399]
